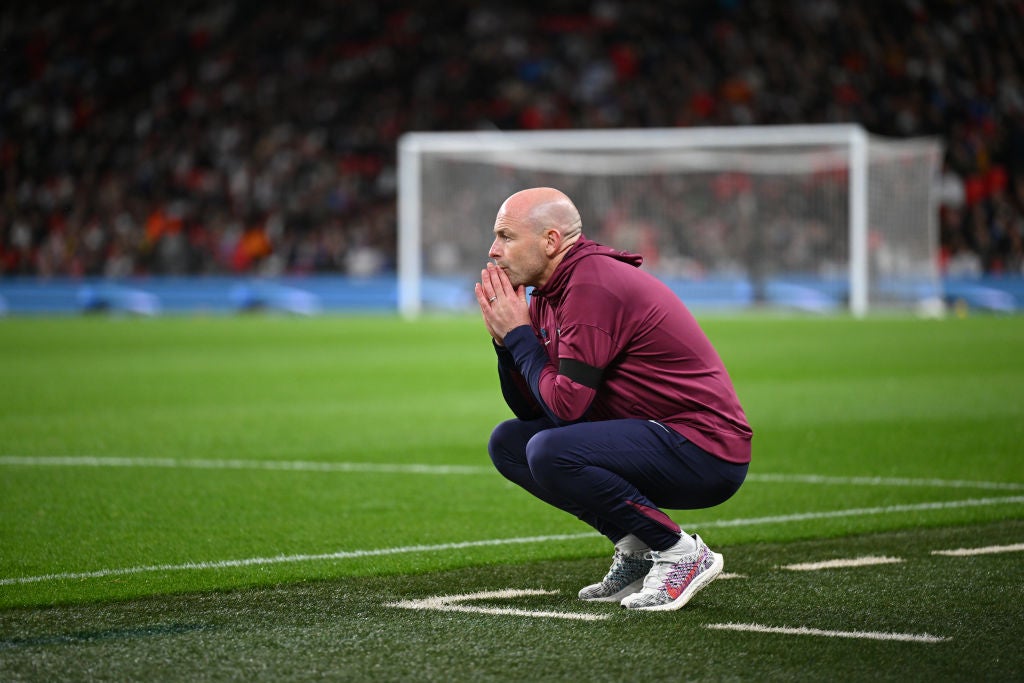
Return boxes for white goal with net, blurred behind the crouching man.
[398,124,942,317]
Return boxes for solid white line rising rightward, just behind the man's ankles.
[0,496,1024,586]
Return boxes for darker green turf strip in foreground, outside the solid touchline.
[0,520,1024,681]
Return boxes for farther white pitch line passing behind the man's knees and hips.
[0,456,1024,490]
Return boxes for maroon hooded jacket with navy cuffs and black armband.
[499,237,753,463]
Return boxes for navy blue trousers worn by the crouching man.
[490,420,746,550]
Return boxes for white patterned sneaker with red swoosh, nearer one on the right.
[622,535,723,610]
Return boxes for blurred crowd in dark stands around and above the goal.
[0,0,1024,278]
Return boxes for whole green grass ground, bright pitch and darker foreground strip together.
[0,315,1024,681]
